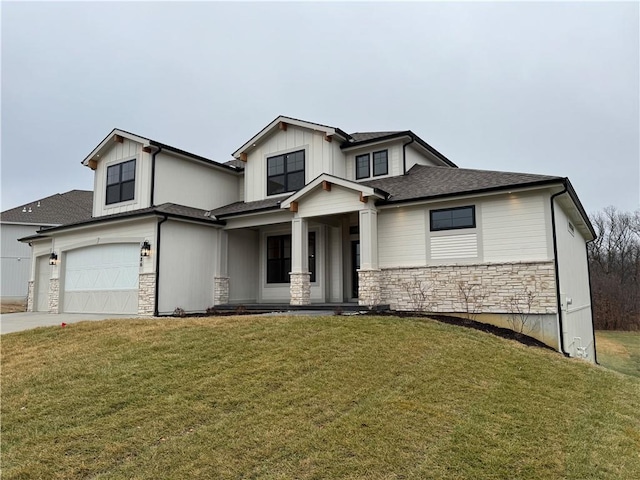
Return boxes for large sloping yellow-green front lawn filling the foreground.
[1,316,640,480]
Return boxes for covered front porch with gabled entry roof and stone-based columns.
[214,175,388,310]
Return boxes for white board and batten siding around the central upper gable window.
[244,125,345,202]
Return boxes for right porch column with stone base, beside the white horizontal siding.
[358,204,382,308]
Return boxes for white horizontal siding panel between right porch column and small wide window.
[378,208,426,268]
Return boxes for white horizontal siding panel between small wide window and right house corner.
[482,195,550,262]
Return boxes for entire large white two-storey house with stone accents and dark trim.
[23,116,595,360]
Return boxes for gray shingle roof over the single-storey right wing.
[362,165,563,203]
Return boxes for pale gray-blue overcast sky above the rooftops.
[0,2,640,216]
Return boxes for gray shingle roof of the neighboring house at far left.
[0,190,93,225]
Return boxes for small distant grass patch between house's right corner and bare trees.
[596,330,640,378]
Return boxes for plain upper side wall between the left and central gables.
[154,152,240,210]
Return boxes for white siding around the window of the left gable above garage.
[93,138,151,217]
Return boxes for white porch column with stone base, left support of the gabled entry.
[289,213,311,305]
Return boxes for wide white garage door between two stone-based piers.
[63,243,140,314]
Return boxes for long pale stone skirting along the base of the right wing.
[380,262,557,314]
